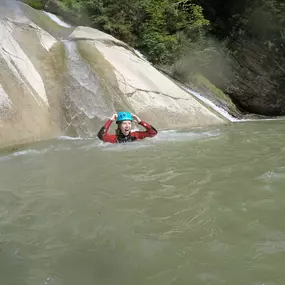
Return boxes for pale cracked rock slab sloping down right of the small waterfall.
[69,27,224,128]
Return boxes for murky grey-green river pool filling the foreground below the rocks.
[0,121,285,285]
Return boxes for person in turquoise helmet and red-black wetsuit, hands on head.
[97,112,157,143]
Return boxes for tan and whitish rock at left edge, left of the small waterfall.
[0,0,66,149]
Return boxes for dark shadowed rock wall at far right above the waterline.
[226,40,285,116]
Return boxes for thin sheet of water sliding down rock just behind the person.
[63,41,115,137]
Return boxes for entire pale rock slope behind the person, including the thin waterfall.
[0,0,227,147]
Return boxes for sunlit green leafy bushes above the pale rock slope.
[57,0,209,64]
